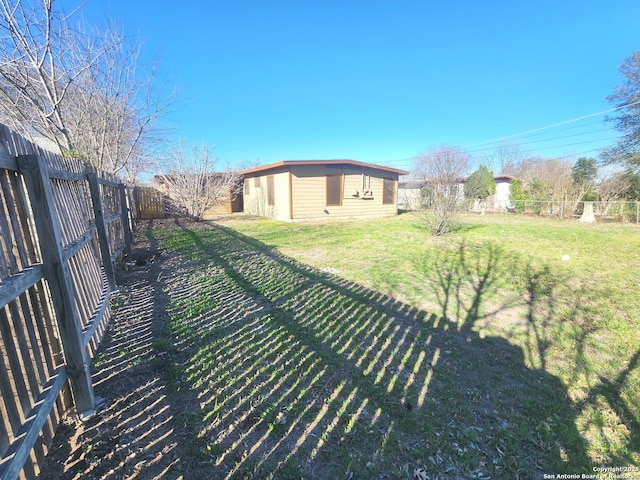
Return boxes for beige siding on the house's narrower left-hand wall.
[244,169,290,220]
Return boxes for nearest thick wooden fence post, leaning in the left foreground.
[18,155,95,415]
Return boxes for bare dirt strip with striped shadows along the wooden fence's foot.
[39,224,181,480]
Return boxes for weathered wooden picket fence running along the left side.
[0,125,132,480]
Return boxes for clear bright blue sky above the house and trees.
[74,0,640,172]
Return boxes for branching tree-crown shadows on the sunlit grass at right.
[422,239,640,465]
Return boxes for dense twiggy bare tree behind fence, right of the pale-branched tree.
[64,20,176,180]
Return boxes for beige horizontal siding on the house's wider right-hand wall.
[291,165,397,220]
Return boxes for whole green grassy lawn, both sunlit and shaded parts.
[145,215,640,479]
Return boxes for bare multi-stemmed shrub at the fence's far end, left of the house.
[157,143,242,220]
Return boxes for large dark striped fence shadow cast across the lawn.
[149,225,591,478]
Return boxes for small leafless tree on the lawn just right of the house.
[412,145,471,235]
